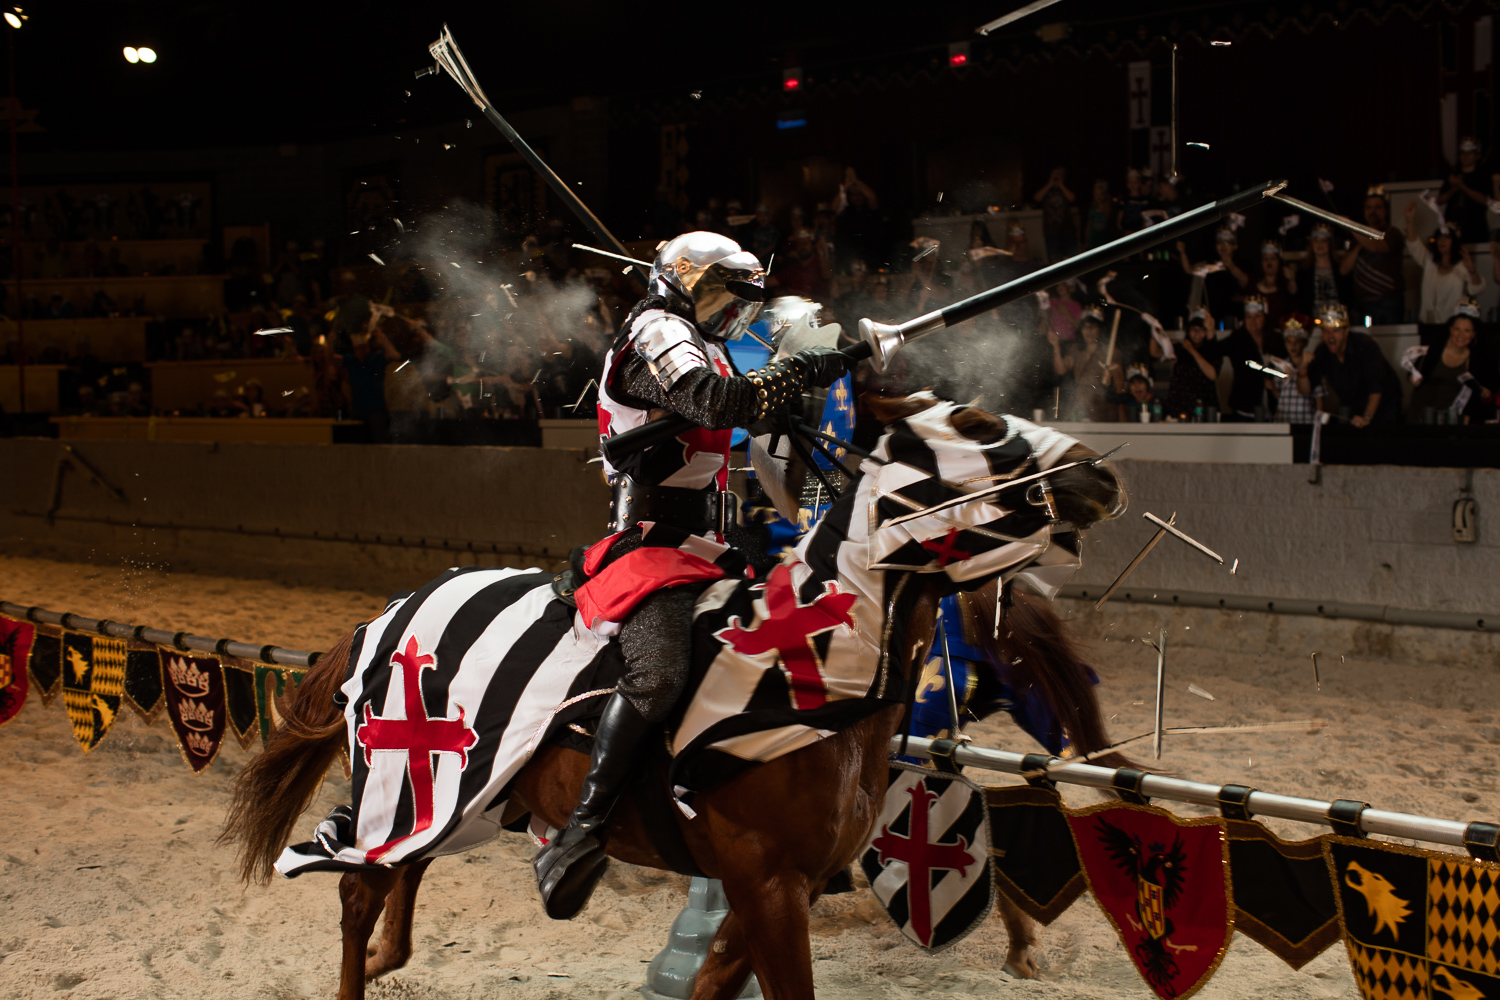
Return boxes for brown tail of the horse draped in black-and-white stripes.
[219,633,354,885]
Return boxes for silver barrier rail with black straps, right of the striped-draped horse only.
[891,736,1500,861]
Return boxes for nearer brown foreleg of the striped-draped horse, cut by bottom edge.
[717,871,821,1000]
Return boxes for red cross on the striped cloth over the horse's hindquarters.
[354,636,479,865]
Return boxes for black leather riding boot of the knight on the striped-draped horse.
[531,694,651,921]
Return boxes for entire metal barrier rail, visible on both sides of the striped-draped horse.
[0,601,1500,861]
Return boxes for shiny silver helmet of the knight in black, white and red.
[651,232,765,340]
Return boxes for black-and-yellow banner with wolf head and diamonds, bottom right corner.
[1323,837,1500,1000]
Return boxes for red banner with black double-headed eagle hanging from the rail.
[1068,802,1235,1000]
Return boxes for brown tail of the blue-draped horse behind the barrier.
[971,583,1133,768]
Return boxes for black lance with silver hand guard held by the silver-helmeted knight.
[599,180,1287,463]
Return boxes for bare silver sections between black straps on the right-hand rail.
[891,736,1469,847]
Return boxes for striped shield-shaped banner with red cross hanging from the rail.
[860,763,995,952]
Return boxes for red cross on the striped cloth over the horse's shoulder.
[714,565,858,711]
